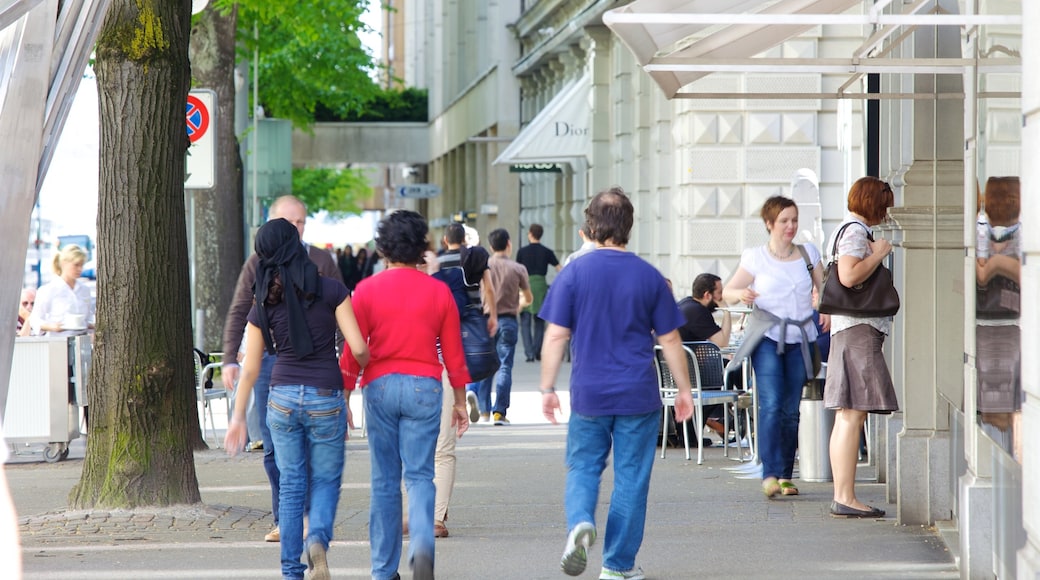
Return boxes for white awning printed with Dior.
[494,74,592,165]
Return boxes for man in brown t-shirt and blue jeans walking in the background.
[474,229,531,425]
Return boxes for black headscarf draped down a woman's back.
[253,218,321,357]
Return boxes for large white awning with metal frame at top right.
[603,0,1021,99]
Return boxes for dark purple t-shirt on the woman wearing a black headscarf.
[248,276,347,389]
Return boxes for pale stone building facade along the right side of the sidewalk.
[406,0,1040,578]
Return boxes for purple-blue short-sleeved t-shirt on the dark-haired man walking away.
[539,249,685,416]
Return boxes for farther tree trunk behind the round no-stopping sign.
[188,3,244,351]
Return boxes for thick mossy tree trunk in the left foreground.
[70,0,201,508]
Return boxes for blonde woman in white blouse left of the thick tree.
[29,244,94,337]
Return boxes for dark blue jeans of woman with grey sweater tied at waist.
[751,338,806,479]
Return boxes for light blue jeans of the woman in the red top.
[363,374,444,580]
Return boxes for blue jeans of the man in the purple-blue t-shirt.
[564,411,660,570]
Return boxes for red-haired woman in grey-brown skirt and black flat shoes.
[824,177,899,518]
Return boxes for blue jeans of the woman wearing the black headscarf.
[267,385,346,579]
